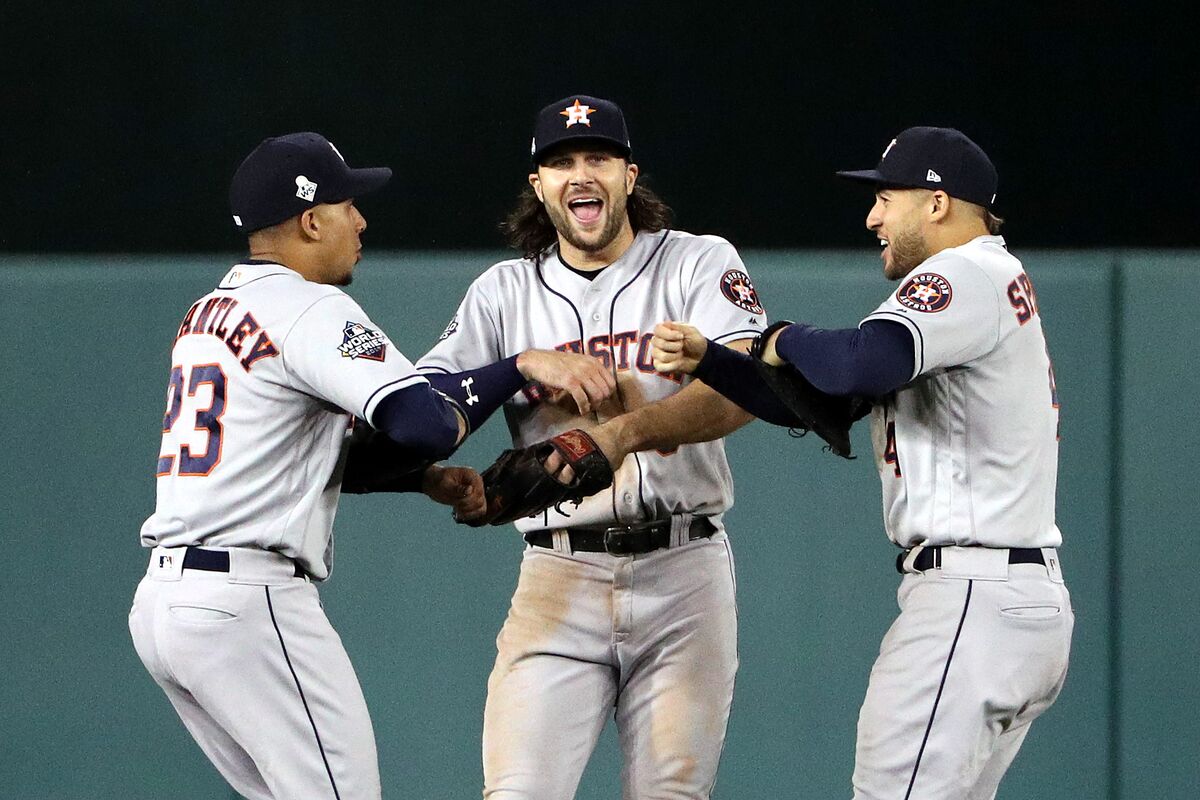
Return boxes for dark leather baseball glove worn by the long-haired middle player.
[472,428,613,525]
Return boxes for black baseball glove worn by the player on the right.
[750,319,871,458]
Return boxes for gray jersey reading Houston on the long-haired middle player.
[419,230,766,531]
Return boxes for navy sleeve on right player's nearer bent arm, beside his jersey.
[775,319,913,397]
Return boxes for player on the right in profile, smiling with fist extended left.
[654,127,1074,800]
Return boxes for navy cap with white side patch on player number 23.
[229,132,391,234]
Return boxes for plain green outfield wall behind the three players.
[0,251,1200,800]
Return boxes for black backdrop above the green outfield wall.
[0,1,1200,252]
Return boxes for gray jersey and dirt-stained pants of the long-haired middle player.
[419,231,766,800]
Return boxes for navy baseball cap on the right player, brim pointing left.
[838,127,998,207]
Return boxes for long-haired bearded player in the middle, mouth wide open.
[418,95,766,800]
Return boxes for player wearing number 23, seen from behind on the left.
[130,133,501,800]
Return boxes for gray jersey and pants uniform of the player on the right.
[853,236,1074,800]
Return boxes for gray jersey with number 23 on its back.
[142,264,428,579]
